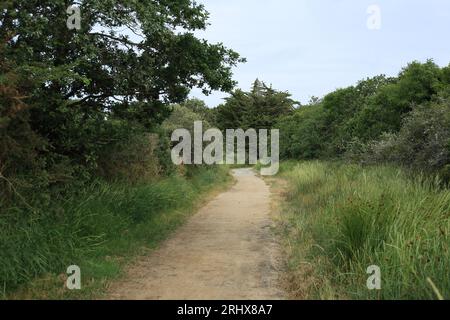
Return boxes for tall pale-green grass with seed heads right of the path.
[280,162,450,299]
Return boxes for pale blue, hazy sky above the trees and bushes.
[191,0,450,107]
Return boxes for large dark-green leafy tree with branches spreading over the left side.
[0,0,243,199]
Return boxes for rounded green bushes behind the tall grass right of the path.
[276,60,450,178]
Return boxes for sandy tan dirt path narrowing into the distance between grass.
[109,169,284,300]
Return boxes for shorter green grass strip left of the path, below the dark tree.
[0,166,231,299]
